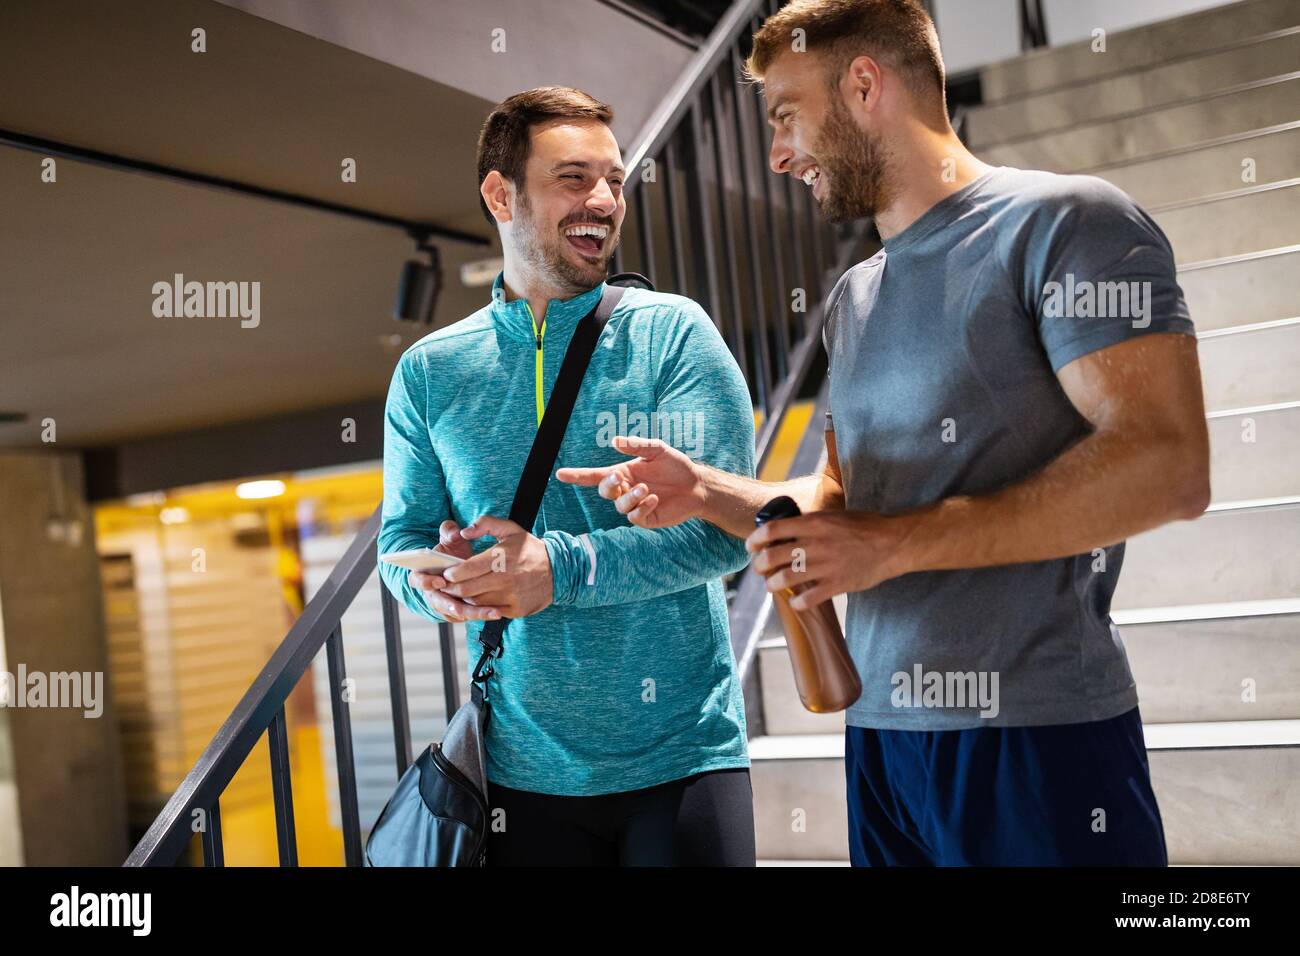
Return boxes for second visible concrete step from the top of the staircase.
[966,26,1300,150]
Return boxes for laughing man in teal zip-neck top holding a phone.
[378,87,754,865]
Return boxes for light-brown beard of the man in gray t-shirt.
[813,91,893,222]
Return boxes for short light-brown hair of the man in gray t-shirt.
[745,0,948,118]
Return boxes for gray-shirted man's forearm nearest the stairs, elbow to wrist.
[894,431,1209,571]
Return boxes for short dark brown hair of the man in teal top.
[478,86,614,226]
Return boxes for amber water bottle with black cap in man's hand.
[754,494,862,714]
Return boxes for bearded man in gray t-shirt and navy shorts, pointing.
[559,0,1209,866]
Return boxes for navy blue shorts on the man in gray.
[844,708,1169,866]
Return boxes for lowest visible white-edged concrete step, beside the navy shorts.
[750,721,1300,865]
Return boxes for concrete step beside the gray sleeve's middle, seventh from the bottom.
[1148,179,1300,263]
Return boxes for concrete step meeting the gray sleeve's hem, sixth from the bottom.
[1178,243,1300,332]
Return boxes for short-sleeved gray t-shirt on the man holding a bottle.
[823,166,1195,730]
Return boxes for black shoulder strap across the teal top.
[473,282,627,689]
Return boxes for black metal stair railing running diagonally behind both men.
[126,0,867,866]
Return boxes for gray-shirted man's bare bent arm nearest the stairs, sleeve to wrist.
[902,333,1210,571]
